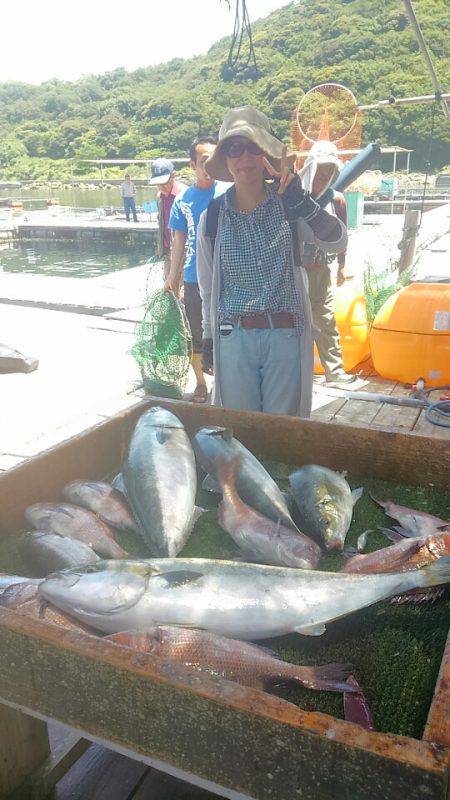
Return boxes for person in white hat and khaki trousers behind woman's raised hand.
[299,141,356,383]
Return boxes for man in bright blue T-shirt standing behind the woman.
[165,136,227,403]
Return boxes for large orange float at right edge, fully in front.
[370,283,450,386]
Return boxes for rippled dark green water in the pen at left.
[0,241,154,278]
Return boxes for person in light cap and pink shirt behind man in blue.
[149,158,187,294]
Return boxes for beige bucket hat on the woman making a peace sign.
[205,106,295,181]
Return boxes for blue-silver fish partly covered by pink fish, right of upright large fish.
[193,427,297,530]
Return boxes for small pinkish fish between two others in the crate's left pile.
[25,503,128,558]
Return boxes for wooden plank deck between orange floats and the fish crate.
[311,373,450,440]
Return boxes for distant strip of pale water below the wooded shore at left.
[0,186,156,210]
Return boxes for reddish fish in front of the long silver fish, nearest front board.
[107,625,359,693]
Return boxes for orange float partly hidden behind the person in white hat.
[314,281,370,375]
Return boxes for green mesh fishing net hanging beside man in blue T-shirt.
[132,289,192,399]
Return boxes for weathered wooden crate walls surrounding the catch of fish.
[0,401,450,800]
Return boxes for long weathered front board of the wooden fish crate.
[0,609,449,800]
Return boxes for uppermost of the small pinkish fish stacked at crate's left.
[63,481,140,533]
